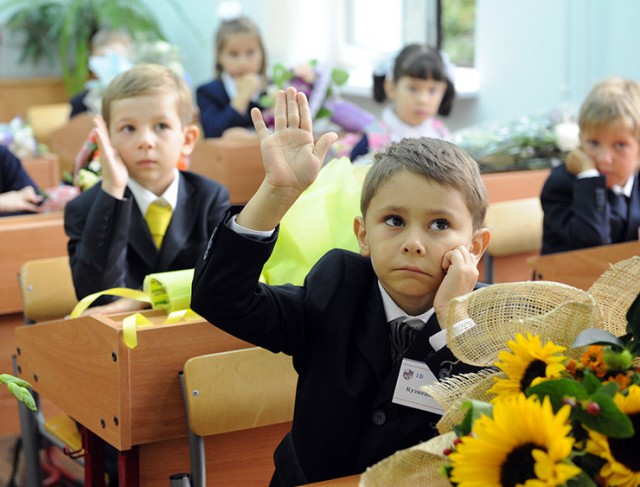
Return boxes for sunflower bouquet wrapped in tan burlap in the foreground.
[360,257,640,487]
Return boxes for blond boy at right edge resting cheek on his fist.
[540,78,640,254]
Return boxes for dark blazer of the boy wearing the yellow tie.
[64,172,229,304]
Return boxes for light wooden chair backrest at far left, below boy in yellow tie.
[18,256,77,322]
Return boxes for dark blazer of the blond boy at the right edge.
[540,164,640,254]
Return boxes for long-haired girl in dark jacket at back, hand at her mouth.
[196,4,267,138]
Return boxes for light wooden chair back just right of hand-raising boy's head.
[484,197,543,283]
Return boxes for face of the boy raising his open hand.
[354,171,486,315]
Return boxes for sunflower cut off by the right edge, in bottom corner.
[587,385,640,487]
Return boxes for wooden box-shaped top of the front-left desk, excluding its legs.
[16,310,251,450]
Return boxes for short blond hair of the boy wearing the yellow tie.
[102,64,193,127]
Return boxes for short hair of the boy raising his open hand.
[360,137,489,231]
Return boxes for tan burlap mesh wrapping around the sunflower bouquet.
[360,256,640,487]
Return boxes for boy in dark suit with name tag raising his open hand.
[191,88,490,487]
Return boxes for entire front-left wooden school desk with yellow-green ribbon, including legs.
[16,310,291,487]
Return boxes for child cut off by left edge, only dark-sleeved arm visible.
[0,145,42,216]
